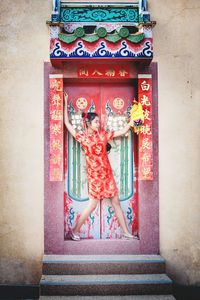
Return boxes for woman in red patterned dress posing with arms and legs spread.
[64,94,134,241]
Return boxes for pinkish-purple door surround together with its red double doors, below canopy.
[44,63,159,254]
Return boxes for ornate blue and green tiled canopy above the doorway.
[47,0,155,64]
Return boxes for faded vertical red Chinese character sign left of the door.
[49,74,63,181]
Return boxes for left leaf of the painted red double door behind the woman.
[65,84,100,239]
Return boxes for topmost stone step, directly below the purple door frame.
[43,255,165,275]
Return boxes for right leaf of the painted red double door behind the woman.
[101,84,138,239]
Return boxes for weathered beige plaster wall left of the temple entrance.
[0,0,51,283]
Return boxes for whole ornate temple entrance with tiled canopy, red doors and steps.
[40,0,171,296]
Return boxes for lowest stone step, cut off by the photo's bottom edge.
[39,295,176,300]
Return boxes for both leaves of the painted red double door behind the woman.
[64,82,138,240]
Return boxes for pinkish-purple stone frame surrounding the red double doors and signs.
[44,63,159,254]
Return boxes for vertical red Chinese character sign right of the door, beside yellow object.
[138,74,153,180]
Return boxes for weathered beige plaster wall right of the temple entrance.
[149,0,200,284]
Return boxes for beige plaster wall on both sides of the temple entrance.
[0,0,200,284]
